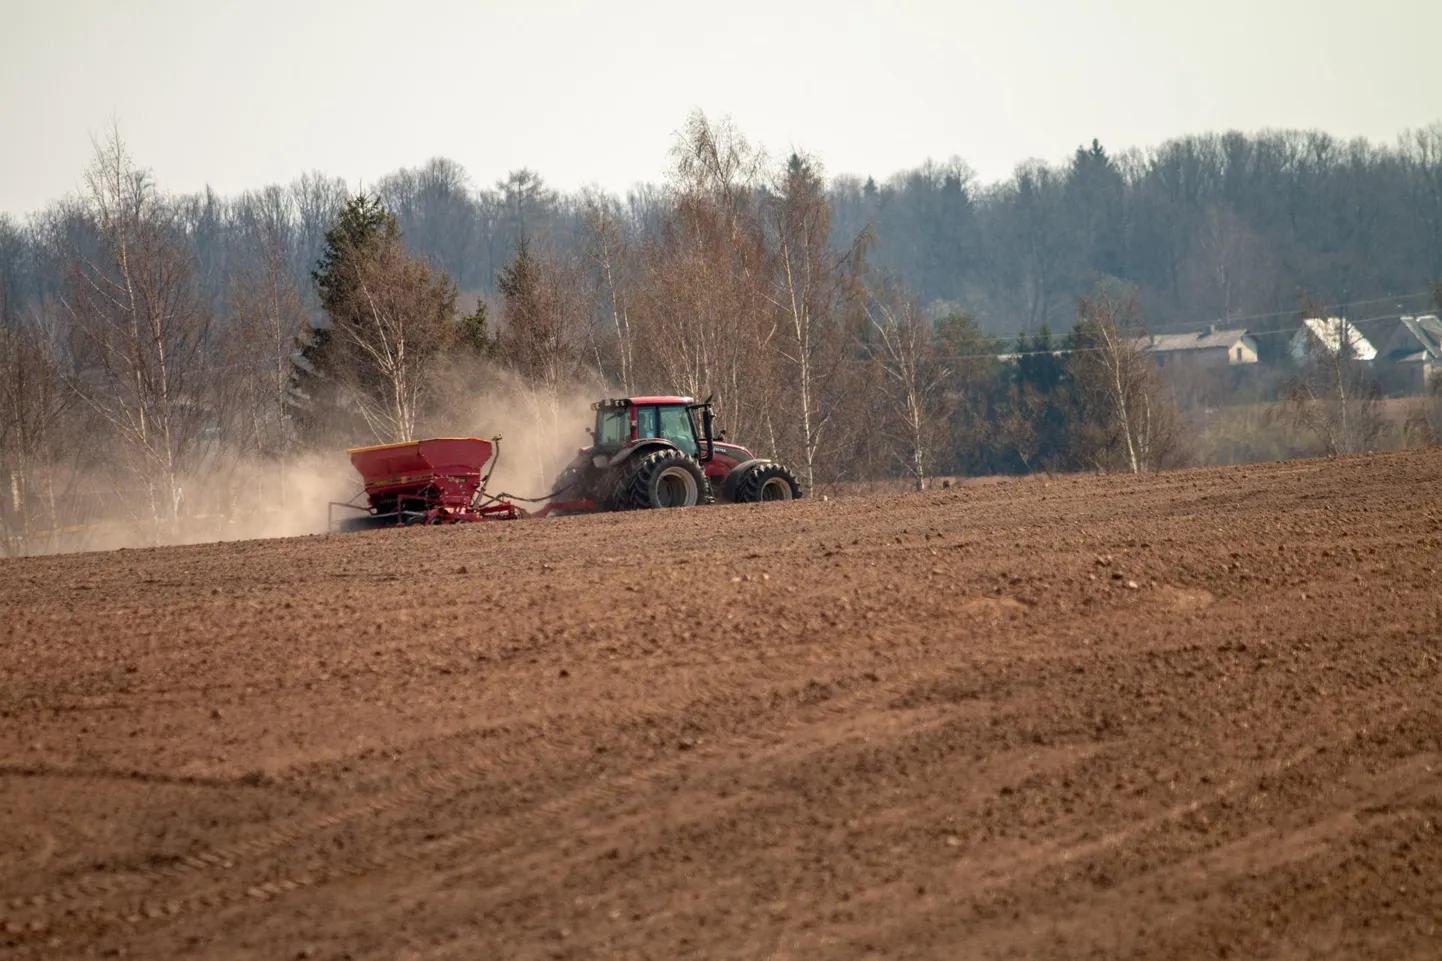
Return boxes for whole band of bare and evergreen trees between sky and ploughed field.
[0,114,1442,553]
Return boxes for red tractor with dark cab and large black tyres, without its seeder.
[551,397,802,512]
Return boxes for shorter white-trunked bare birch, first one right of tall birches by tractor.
[864,281,950,491]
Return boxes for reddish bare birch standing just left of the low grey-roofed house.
[1067,284,1181,473]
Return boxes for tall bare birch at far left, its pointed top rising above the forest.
[65,123,215,535]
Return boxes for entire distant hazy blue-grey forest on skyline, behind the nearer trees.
[0,123,1442,338]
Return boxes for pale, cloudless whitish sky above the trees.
[0,0,1442,214]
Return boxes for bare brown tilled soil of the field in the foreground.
[0,452,1442,961]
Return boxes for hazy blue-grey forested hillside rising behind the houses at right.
[832,124,1442,341]
